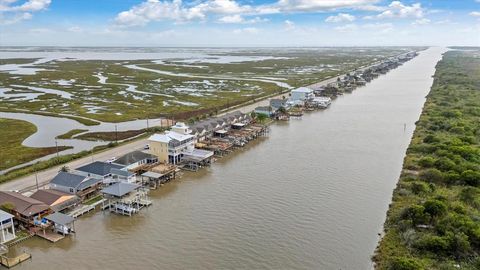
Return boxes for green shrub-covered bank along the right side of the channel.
[374,51,480,269]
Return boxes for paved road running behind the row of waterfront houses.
[0,58,394,192]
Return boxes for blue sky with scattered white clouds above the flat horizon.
[0,0,480,47]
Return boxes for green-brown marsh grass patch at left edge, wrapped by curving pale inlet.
[0,118,68,170]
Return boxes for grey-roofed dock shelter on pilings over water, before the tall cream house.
[102,182,152,216]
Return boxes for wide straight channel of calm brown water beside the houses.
[10,48,444,270]
